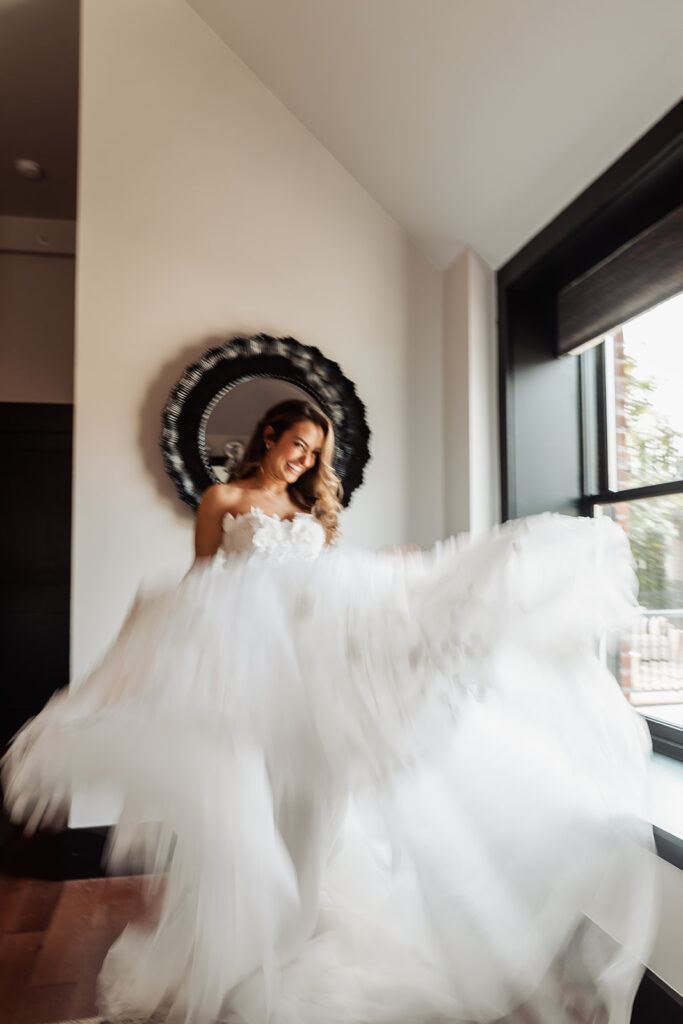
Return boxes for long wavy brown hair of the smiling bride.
[228,398,342,544]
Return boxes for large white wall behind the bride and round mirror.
[73,0,442,673]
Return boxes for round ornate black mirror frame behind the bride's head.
[160,334,370,508]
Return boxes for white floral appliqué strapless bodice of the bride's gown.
[221,507,325,561]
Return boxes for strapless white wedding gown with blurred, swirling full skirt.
[4,509,654,1024]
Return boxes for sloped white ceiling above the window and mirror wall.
[187,0,683,267]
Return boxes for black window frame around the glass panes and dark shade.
[497,101,683,761]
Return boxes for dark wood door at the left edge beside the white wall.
[0,402,73,745]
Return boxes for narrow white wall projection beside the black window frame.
[443,248,500,534]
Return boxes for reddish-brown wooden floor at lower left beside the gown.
[0,877,142,1024]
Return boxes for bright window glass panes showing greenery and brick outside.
[581,293,683,757]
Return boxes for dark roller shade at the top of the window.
[557,199,683,355]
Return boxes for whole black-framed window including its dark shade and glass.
[497,100,683,774]
